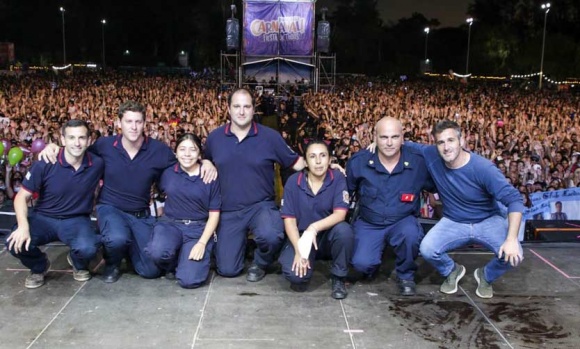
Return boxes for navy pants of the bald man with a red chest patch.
[352,216,425,280]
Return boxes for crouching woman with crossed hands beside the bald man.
[280,141,354,299]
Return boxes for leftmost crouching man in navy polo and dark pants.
[6,120,104,288]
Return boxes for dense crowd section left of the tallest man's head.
[0,73,227,207]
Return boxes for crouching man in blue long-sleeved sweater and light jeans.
[414,121,524,298]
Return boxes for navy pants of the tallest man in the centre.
[215,201,284,277]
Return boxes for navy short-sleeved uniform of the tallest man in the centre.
[205,122,299,276]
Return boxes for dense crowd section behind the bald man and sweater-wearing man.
[296,81,580,192]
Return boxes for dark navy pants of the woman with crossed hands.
[278,222,354,284]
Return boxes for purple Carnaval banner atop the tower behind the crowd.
[244,1,314,56]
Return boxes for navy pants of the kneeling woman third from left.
[145,218,214,288]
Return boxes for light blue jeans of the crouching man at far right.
[421,216,523,283]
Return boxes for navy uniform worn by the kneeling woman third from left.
[146,164,221,288]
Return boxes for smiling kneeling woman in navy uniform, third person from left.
[147,133,221,288]
